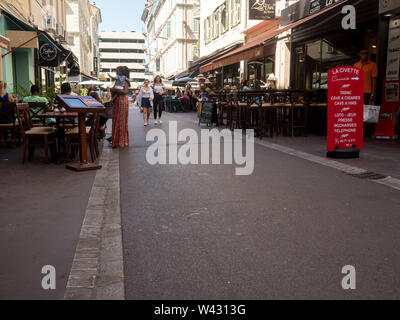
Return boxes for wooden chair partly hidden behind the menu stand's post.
[65,112,100,162]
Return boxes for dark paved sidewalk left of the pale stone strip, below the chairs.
[0,138,101,299]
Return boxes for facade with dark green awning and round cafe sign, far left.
[0,0,70,93]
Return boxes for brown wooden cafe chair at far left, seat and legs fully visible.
[17,104,57,163]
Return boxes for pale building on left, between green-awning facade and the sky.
[66,0,93,82]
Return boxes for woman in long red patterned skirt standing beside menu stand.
[110,66,131,148]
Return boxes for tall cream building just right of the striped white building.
[142,0,199,79]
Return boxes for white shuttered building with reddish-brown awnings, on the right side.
[200,0,296,88]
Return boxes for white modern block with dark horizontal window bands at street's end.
[99,31,145,88]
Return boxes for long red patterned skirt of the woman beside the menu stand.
[112,94,129,148]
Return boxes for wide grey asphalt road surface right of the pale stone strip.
[120,109,400,299]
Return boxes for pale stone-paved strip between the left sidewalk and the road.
[64,127,125,300]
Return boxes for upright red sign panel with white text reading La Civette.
[327,66,364,151]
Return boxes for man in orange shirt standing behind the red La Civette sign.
[354,48,378,104]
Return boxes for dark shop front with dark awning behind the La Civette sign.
[290,0,379,90]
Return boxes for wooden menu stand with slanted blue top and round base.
[56,95,105,171]
